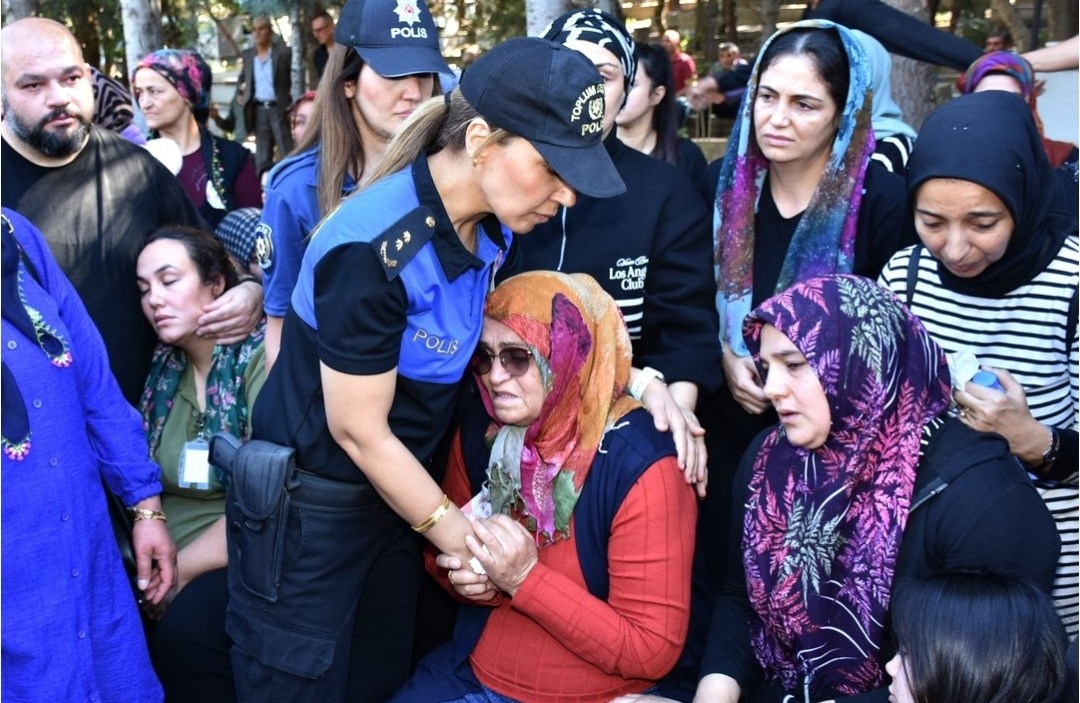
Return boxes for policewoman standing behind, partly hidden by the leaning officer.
[257,0,450,367]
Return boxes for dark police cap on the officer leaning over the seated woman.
[460,38,626,198]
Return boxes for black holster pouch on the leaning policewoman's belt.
[210,432,299,603]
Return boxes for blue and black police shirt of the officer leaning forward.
[253,156,511,482]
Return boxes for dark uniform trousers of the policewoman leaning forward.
[226,474,421,703]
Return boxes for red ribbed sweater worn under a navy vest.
[438,436,698,703]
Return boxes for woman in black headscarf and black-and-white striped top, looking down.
[881,91,1080,636]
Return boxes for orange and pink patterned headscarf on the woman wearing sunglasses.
[481,271,638,546]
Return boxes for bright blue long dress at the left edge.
[0,208,162,703]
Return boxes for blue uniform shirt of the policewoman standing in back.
[255,147,356,317]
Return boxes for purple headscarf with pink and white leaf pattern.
[742,275,950,700]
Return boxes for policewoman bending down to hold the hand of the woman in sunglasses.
[227,39,624,702]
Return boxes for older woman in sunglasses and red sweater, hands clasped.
[394,271,697,703]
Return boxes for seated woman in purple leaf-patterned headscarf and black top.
[699,275,1057,702]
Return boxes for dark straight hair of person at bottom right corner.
[892,572,1068,703]
